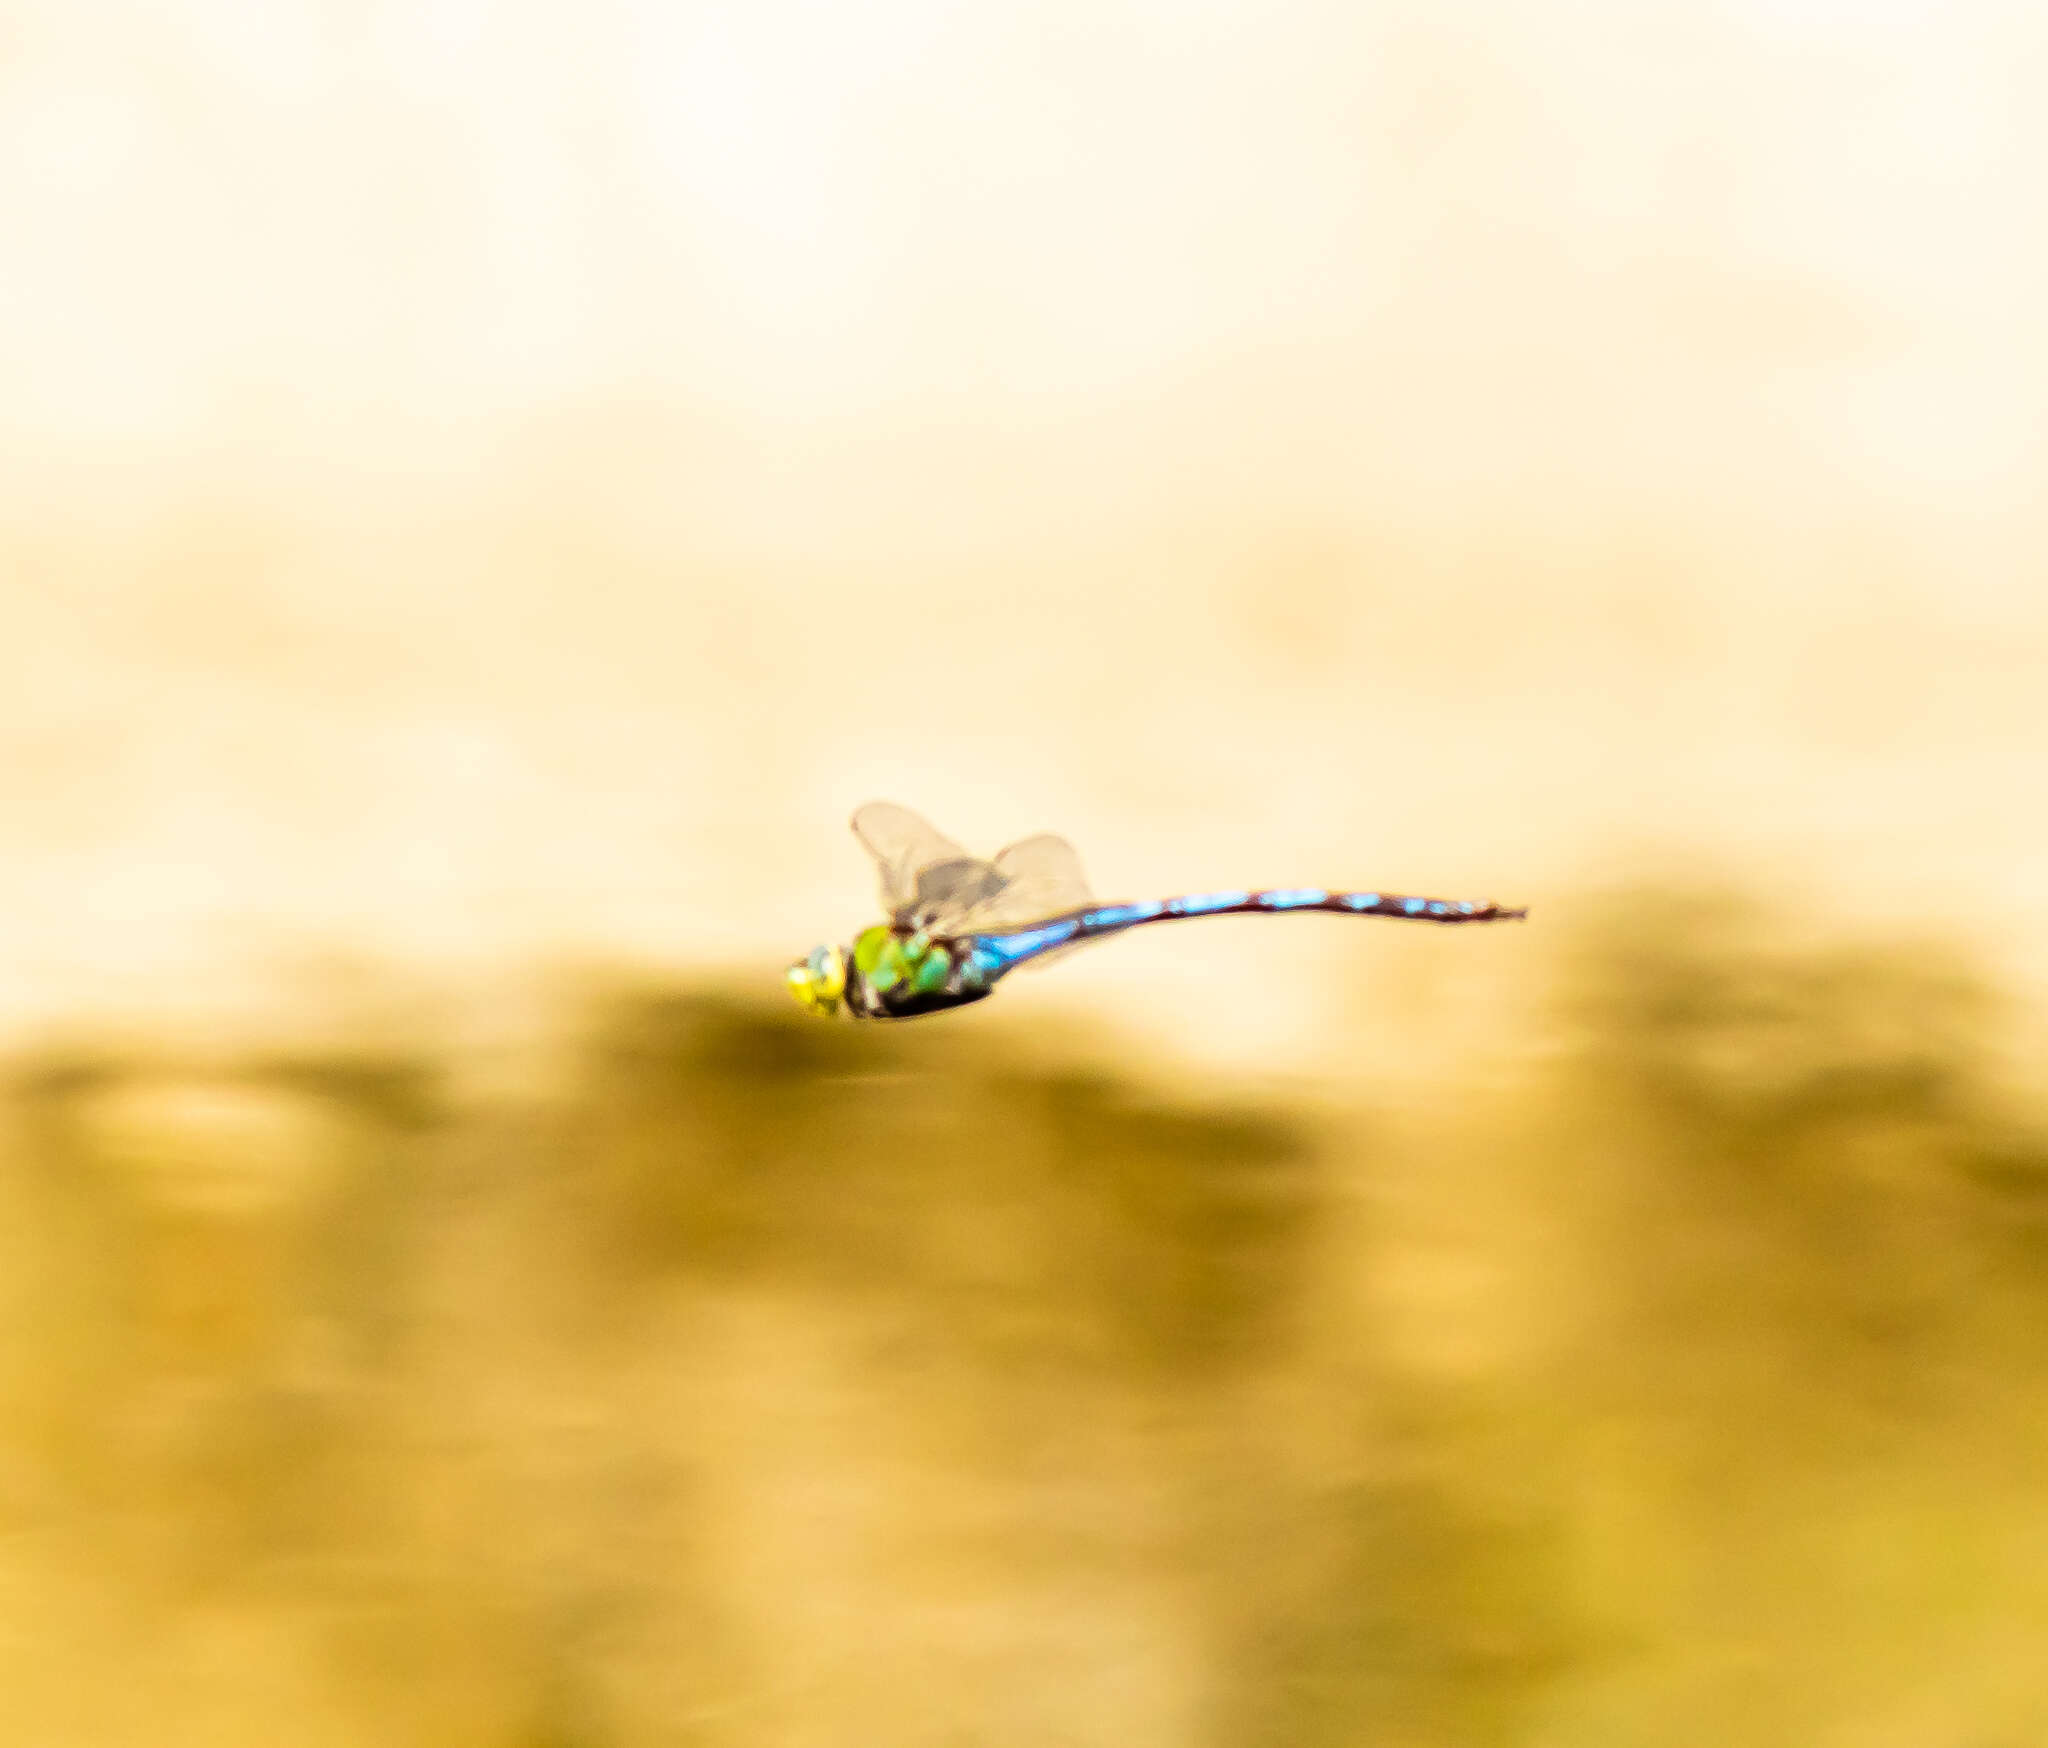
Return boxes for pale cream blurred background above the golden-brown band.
[0,0,2048,1052]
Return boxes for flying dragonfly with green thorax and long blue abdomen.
[784,800,1528,1019]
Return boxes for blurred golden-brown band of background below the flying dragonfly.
[0,890,2048,1748]
